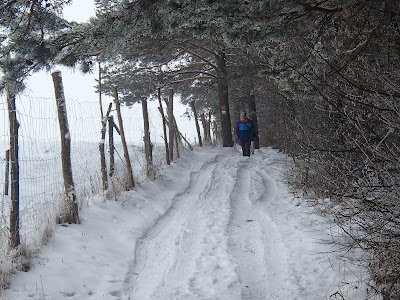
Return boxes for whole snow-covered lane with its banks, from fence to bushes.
[2,147,366,300]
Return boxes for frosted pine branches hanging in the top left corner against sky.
[0,0,70,93]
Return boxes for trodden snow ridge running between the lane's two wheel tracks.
[178,157,240,299]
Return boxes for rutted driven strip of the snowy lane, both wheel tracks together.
[125,149,286,299]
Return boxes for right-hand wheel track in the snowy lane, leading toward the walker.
[229,155,288,300]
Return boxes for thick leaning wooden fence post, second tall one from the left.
[51,71,79,223]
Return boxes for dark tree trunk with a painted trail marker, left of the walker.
[216,49,233,147]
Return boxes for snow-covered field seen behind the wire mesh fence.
[0,140,164,251]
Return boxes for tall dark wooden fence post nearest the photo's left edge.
[7,91,20,248]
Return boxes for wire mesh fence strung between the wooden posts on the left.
[0,96,172,271]
